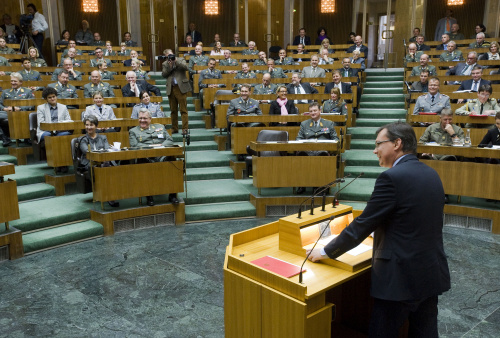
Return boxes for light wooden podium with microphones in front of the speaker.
[224,205,372,338]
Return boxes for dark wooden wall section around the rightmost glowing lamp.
[424,0,488,40]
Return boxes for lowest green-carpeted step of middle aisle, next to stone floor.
[186,202,256,222]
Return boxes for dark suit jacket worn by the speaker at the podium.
[325,154,450,301]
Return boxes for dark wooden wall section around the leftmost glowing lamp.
[60,0,118,46]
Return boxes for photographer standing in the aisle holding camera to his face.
[161,49,191,134]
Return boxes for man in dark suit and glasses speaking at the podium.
[309,122,451,337]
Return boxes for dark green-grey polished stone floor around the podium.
[0,219,500,338]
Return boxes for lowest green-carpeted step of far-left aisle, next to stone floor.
[23,220,104,253]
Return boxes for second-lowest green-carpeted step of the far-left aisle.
[10,194,97,231]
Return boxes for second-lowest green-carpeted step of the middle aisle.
[179,179,250,205]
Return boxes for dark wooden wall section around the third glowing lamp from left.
[300,0,361,44]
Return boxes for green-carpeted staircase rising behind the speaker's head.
[340,68,406,201]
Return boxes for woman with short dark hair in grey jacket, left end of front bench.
[77,115,120,208]
